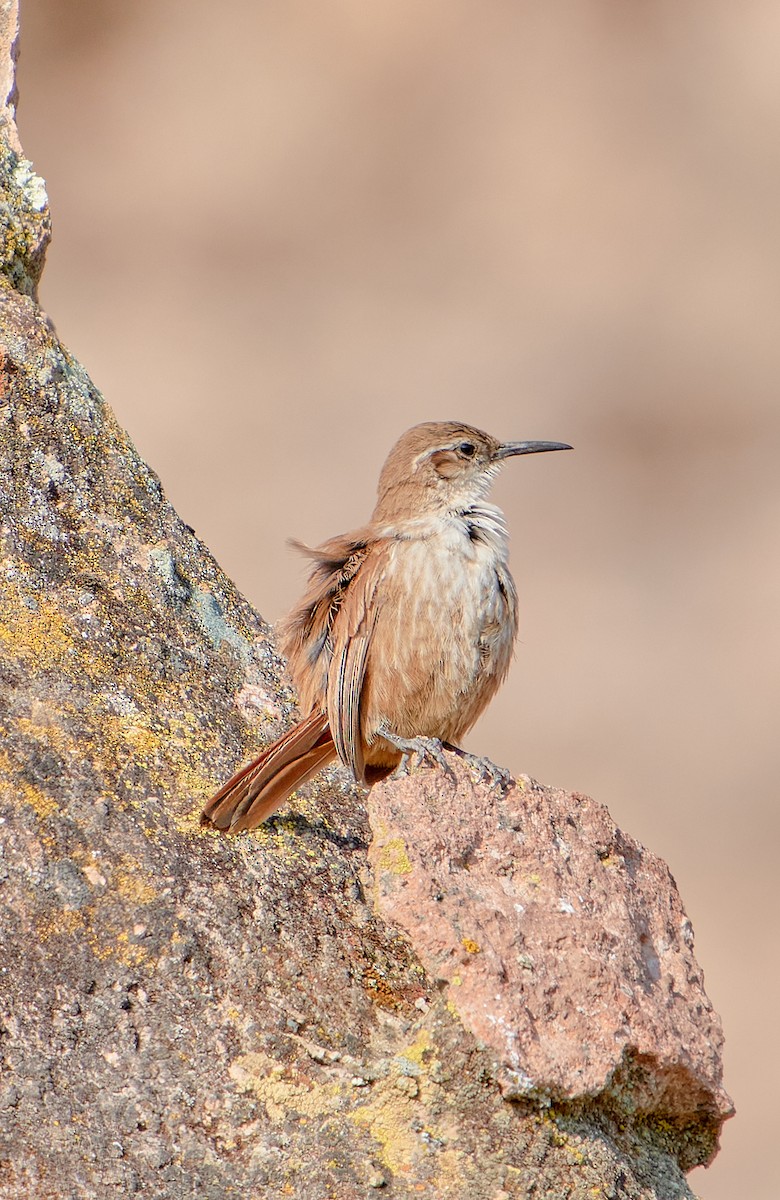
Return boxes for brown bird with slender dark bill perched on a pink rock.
[200,421,571,833]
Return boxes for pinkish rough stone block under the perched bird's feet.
[368,762,732,1147]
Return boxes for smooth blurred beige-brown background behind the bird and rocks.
[19,0,780,1200]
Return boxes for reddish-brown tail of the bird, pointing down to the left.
[200,713,336,833]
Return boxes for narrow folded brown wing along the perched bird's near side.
[326,544,386,782]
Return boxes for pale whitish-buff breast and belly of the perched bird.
[361,535,516,742]
